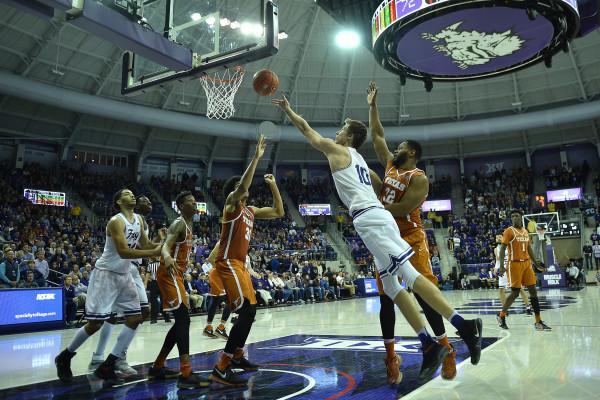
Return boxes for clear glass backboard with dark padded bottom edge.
[121,0,279,95]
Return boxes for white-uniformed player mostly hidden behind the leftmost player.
[88,196,166,375]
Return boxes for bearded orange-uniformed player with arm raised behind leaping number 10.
[367,82,456,384]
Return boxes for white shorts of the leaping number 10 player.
[353,207,420,287]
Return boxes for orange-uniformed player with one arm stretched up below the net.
[208,135,284,386]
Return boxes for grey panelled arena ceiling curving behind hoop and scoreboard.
[0,0,600,159]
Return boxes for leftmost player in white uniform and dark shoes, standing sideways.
[54,189,162,383]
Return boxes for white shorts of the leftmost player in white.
[85,269,141,321]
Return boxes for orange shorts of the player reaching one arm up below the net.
[215,259,256,312]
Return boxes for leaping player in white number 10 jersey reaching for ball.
[272,97,483,379]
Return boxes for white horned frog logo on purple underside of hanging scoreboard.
[421,21,525,69]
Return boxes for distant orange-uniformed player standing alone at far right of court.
[498,210,552,331]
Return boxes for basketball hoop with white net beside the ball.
[200,66,246,119]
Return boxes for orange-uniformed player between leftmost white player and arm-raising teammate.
[148,191,210,389]
